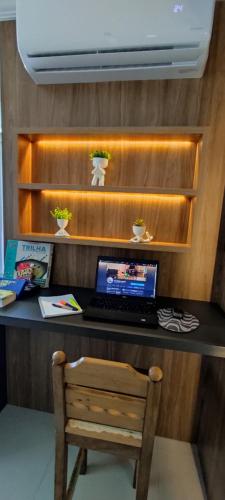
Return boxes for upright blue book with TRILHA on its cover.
[4,240,53,288]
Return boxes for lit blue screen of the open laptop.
[96,257,158,299]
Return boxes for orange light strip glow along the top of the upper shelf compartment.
[35,138,193,149]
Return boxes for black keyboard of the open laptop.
[91,297,155,314]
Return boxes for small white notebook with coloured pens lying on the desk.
[38,293,83,318]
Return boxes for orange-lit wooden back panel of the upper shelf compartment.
[29,135,196,188]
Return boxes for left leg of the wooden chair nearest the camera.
[54,433,68,500]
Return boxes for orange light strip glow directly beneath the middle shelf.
[41,190,187,203]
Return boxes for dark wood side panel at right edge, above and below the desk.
[197,97,225,500]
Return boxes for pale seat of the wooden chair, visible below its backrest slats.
[65,419,142,448]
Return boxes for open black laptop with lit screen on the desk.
[83,257,159,328]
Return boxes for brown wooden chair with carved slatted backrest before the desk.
[52,351,163,500]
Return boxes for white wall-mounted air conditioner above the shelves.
[16,0,215,84]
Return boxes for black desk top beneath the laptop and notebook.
[0,286,225,358]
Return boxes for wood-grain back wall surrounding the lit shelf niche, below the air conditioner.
[0,2,225,300]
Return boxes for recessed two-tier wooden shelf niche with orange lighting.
[16,127,203,252]
